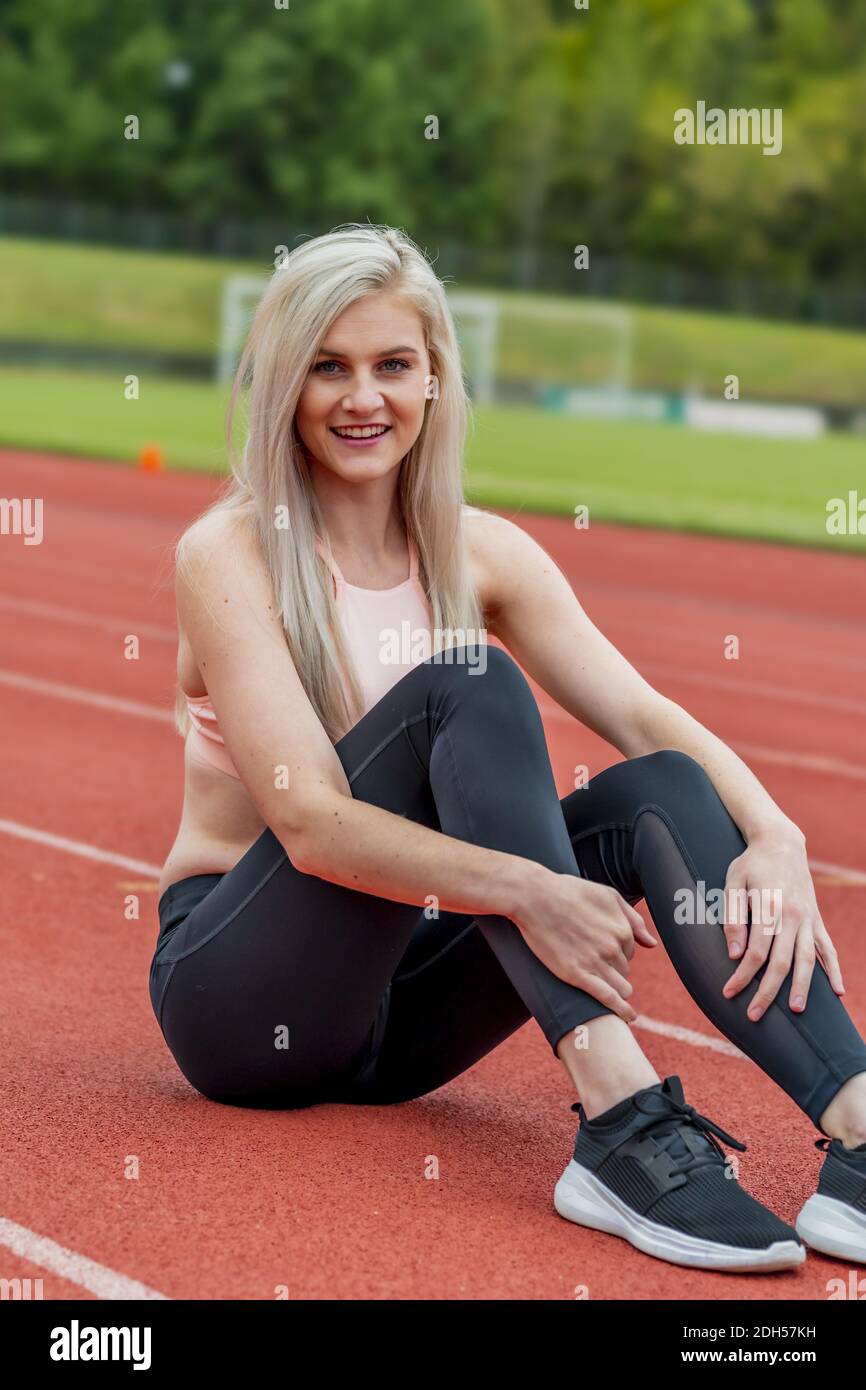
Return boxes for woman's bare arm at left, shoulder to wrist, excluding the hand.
[178,518,544,919]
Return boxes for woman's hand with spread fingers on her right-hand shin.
[721,831,845,1022]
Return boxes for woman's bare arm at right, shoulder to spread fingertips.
[485,518,845,1019]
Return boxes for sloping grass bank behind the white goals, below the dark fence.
[0,238,866,406]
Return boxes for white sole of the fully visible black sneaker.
[553,1159,806,1273]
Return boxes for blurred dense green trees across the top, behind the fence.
[0,0,866,284]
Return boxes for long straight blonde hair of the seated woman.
[174,222,492,742]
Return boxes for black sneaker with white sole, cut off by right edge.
[795,1137,866,1264]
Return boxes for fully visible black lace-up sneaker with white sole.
[553,1076,806,1273]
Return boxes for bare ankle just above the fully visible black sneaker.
[556,1013,662,1119]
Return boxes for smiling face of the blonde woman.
[295,292,430,482]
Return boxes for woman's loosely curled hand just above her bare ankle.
[512,870,657,1023]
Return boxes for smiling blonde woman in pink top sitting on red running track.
[150,225,866,1270]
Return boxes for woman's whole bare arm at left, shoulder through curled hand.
[178,517,644,1022]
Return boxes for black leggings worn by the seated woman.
[150,646,866,1129]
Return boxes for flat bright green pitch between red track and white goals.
[0,370,866,550]
